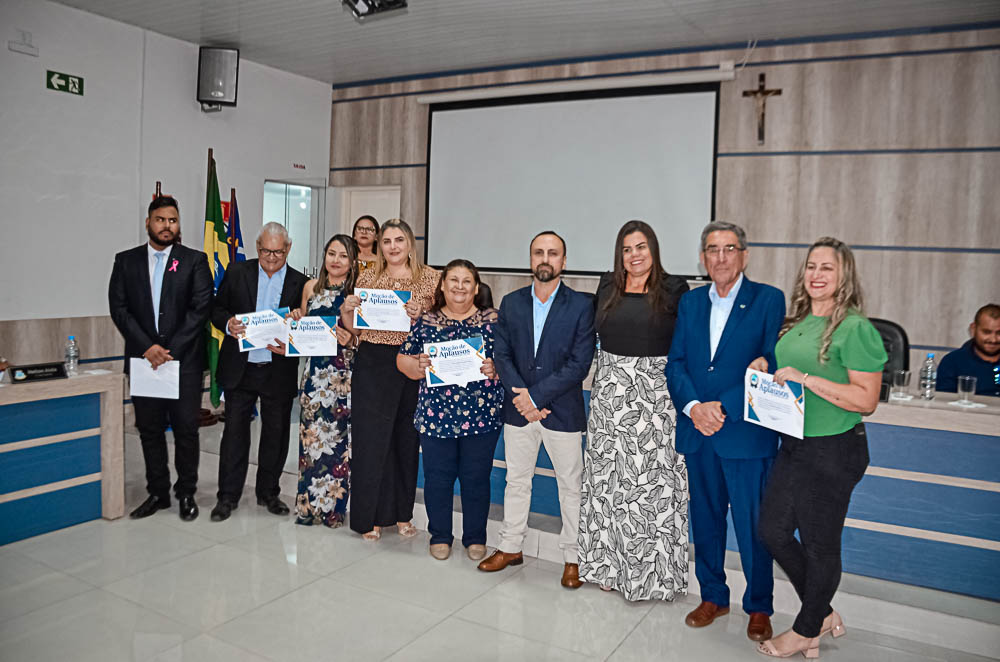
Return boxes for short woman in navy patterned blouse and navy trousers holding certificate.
[396,260,504,561]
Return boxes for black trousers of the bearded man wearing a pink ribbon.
[132,371,202,499]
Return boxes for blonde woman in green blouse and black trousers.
[750,237,887,657]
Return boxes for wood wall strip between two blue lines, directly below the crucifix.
[716,153,1000,248]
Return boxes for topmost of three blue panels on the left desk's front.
[0,394,101,444]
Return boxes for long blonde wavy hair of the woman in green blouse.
[778,237,864,363]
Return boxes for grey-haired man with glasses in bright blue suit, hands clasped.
[665,222,785,641]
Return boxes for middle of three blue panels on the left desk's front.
[0,435,101,494]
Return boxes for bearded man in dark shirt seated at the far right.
[937,303,1000,396]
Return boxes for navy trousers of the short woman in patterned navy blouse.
[420,430,500,547]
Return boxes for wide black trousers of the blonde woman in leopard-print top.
[350,342,420,533]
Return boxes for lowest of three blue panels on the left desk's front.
[0,482,101,545]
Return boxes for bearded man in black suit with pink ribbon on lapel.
[108,196,212,521]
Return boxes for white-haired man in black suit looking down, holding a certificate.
[212,223,306,522]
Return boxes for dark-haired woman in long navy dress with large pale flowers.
[292,234,357,528]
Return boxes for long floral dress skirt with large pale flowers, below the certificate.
[295,351,351,528]
